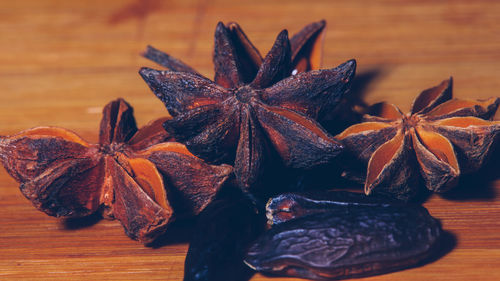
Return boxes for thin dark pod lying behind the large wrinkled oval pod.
[266,191,405,225]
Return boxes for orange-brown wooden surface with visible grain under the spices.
[0,0,500,281]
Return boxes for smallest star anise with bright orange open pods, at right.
[337,78,500,200]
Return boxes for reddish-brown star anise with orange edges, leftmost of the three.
[0,99,232,243]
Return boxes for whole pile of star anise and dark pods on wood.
[0,21,500,281]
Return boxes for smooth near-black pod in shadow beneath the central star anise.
[184,188,265,281]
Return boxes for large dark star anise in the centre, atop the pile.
[140,23,356,190]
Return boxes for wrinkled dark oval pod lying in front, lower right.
[245,203,442,280]
